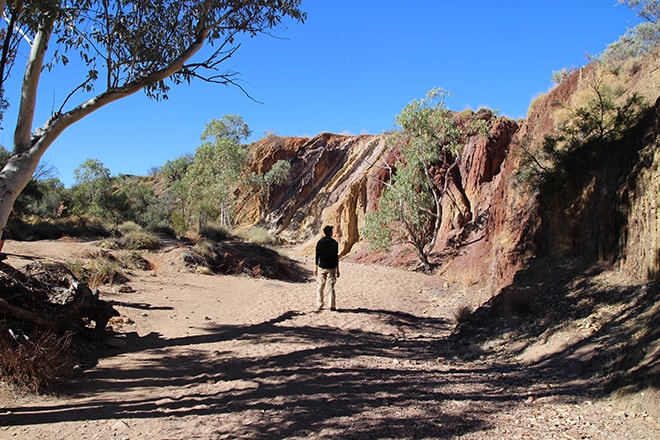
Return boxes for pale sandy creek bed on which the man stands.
[0,240,660,440]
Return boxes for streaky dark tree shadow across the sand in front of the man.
[0,300,640,439]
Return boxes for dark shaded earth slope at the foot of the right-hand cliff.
[449,258,660,398]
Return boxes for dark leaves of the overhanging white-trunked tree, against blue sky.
[0,0,306,124]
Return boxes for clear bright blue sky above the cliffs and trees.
[0,0,640,186]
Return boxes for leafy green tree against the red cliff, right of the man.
[363,89,487,267]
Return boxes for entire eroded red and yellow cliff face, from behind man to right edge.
[242,51,660,295]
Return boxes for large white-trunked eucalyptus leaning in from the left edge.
[0,0,306,237]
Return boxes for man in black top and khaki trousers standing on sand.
[314,225,339,311]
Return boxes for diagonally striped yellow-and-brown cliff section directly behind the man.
[242,133,385,256]
